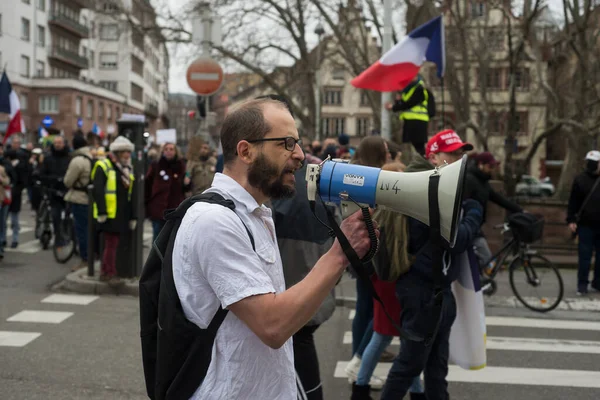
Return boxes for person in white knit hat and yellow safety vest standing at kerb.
[91,136,138,285]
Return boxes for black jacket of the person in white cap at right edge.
[567,171,600,226]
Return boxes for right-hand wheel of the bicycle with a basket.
[509,254,564,312]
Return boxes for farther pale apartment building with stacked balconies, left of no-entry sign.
[80,0,169,133]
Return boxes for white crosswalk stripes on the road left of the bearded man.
[0,293,98,348]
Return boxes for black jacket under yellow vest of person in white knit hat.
[93,155,138,233]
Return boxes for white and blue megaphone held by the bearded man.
[306,155,467,247]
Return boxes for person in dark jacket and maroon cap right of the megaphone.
[463,151,523,274]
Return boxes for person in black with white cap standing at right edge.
[567,150,600,296]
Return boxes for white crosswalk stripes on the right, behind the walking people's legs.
[334,311,600,394]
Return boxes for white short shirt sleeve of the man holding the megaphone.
[188,205,276,308]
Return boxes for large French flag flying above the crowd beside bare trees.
[350,15,446,92]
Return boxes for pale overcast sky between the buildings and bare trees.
[165,0,562,94]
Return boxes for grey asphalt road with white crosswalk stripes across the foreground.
[0,214,600,400]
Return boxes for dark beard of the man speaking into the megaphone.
[248,154,296,199]
